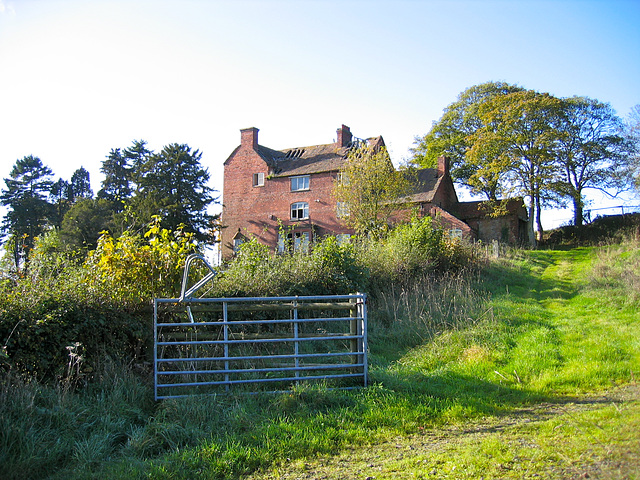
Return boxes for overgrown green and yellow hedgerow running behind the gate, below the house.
[0,218,468,379]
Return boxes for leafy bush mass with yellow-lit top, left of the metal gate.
[0,220,195,379]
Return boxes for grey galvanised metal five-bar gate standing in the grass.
[153,294,367,400]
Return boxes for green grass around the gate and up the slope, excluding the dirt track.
[0,227,640,479]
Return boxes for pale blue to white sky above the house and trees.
[0,0,640,226]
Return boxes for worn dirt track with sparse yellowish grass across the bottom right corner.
[246,383,640,480]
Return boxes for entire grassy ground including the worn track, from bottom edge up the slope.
[0,240,640,479]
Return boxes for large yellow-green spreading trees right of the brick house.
[413,82,640,237]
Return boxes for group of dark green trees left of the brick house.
[0,140,217,268]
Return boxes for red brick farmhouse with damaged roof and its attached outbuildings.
[221,125,528,258]
